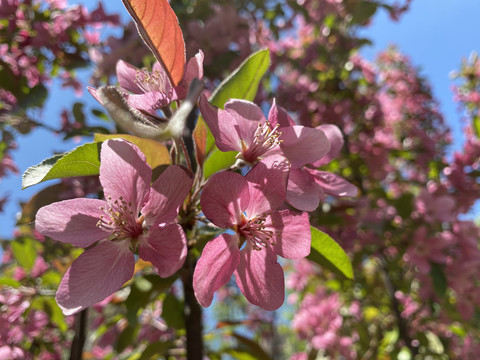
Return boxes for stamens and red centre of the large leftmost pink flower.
[97,196,144,249]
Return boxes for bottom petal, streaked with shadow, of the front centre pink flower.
[235,244,285,310]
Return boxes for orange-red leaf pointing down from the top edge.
[122,0,186,85]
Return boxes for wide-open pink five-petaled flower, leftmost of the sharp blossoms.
[35,140,193,315]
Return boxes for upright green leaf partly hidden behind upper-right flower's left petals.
[197,49,270,179]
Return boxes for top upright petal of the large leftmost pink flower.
[100,140,152,214]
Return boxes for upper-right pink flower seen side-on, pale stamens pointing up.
[199,95,330,166]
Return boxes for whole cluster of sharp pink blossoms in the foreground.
[36,45,357,314]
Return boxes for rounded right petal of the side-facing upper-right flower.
[280,125,330,167]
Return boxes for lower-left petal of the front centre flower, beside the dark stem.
[193,234,240,307]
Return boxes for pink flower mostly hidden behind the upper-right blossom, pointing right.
[272,107,357,211]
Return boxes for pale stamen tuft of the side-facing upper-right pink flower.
[242,120,282,163]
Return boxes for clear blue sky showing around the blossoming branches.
[0,0,480,238]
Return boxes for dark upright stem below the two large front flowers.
[182,251,203,360]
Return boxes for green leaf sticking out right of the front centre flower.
[307,226,353,279]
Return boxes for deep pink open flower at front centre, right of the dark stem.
[193,155,311,310]
